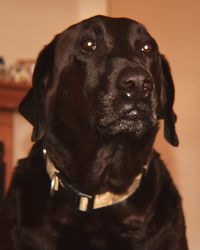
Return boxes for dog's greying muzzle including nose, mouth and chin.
[98,64,157,137]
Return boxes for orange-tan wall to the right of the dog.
[109,0,200,250]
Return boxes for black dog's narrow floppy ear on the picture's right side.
[161,55,179,146]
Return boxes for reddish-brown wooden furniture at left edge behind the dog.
[0,80,30,188]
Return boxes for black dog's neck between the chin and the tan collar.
[45,129,157,194]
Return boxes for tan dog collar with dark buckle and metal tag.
[43,155,149,212]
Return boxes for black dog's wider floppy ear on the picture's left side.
[19,39,56,141]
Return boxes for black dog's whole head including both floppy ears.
[19,16,178,146]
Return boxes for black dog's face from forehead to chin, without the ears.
[55,17,161,140]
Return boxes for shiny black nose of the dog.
[116,67,153,98]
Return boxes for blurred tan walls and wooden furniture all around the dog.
[0,0,200,250]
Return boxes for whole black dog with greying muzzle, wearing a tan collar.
[0,16,188,250]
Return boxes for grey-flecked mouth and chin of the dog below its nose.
[97,95,157,137]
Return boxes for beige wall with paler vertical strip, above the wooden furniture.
[0,0,107,64]
